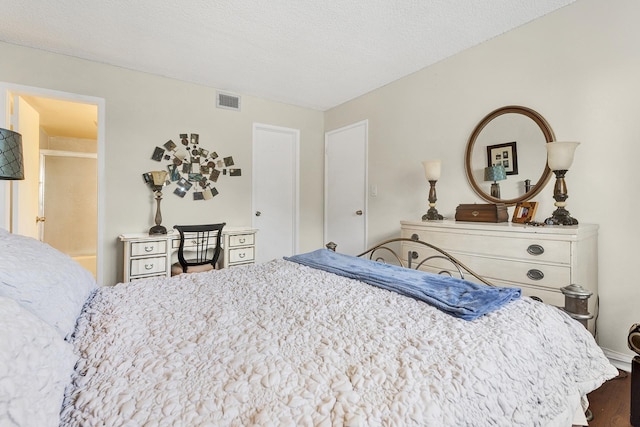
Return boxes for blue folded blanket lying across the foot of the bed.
[285,249,521,320]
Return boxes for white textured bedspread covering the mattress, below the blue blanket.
[62,260,617,427]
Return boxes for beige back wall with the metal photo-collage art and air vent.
[0,43,324,285]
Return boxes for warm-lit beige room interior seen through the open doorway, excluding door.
[22,95,98,277]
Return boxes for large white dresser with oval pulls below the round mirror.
[401,220,598,333]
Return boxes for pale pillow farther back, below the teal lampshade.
[0,229,96,338]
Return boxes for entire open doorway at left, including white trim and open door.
[0,84,104,283]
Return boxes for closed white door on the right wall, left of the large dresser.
[324,120,369,255]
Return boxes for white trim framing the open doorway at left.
[0,82,106,285]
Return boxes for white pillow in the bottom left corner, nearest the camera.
[0,297,77,426]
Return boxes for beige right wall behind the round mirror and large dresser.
[325,0,640,361]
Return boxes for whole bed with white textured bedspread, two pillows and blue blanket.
[0,230,617,426]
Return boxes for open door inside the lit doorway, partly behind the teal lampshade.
[11,96,40,239]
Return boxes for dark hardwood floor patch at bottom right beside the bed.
[588,371,631,427]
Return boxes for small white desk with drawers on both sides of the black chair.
[119,227,258,282]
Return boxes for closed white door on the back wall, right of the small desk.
[253,124,300,263]
